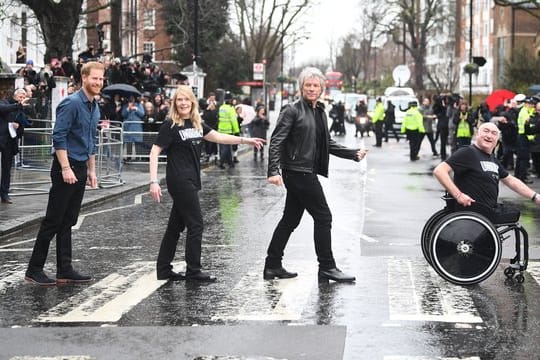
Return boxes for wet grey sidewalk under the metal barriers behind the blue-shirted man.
[0,164,155,242]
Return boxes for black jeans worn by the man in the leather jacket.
[265,170,336,270]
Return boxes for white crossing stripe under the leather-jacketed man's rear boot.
[212,261,318,321]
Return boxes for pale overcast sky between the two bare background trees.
[294,0,362,66]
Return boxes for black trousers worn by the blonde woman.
[156,189,203,274]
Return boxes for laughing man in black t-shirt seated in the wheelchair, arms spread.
[433,123,540,224]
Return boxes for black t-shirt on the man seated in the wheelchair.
[445,145,508,208]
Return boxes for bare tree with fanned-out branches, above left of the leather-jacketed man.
[234,0,312,67]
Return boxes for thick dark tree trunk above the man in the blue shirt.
[21,0,83,63]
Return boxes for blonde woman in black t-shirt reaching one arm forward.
[150,85,264,281]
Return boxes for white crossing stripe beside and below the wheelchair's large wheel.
[388,258,483,323]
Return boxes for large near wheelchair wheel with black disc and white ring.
[429,211,502,285]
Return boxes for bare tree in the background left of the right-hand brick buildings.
[380,0,445,90]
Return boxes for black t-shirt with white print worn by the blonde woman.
[154,119,212,192]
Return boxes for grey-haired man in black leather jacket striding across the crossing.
[263,67,366,282]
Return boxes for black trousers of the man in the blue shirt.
[28,157,87,274]
